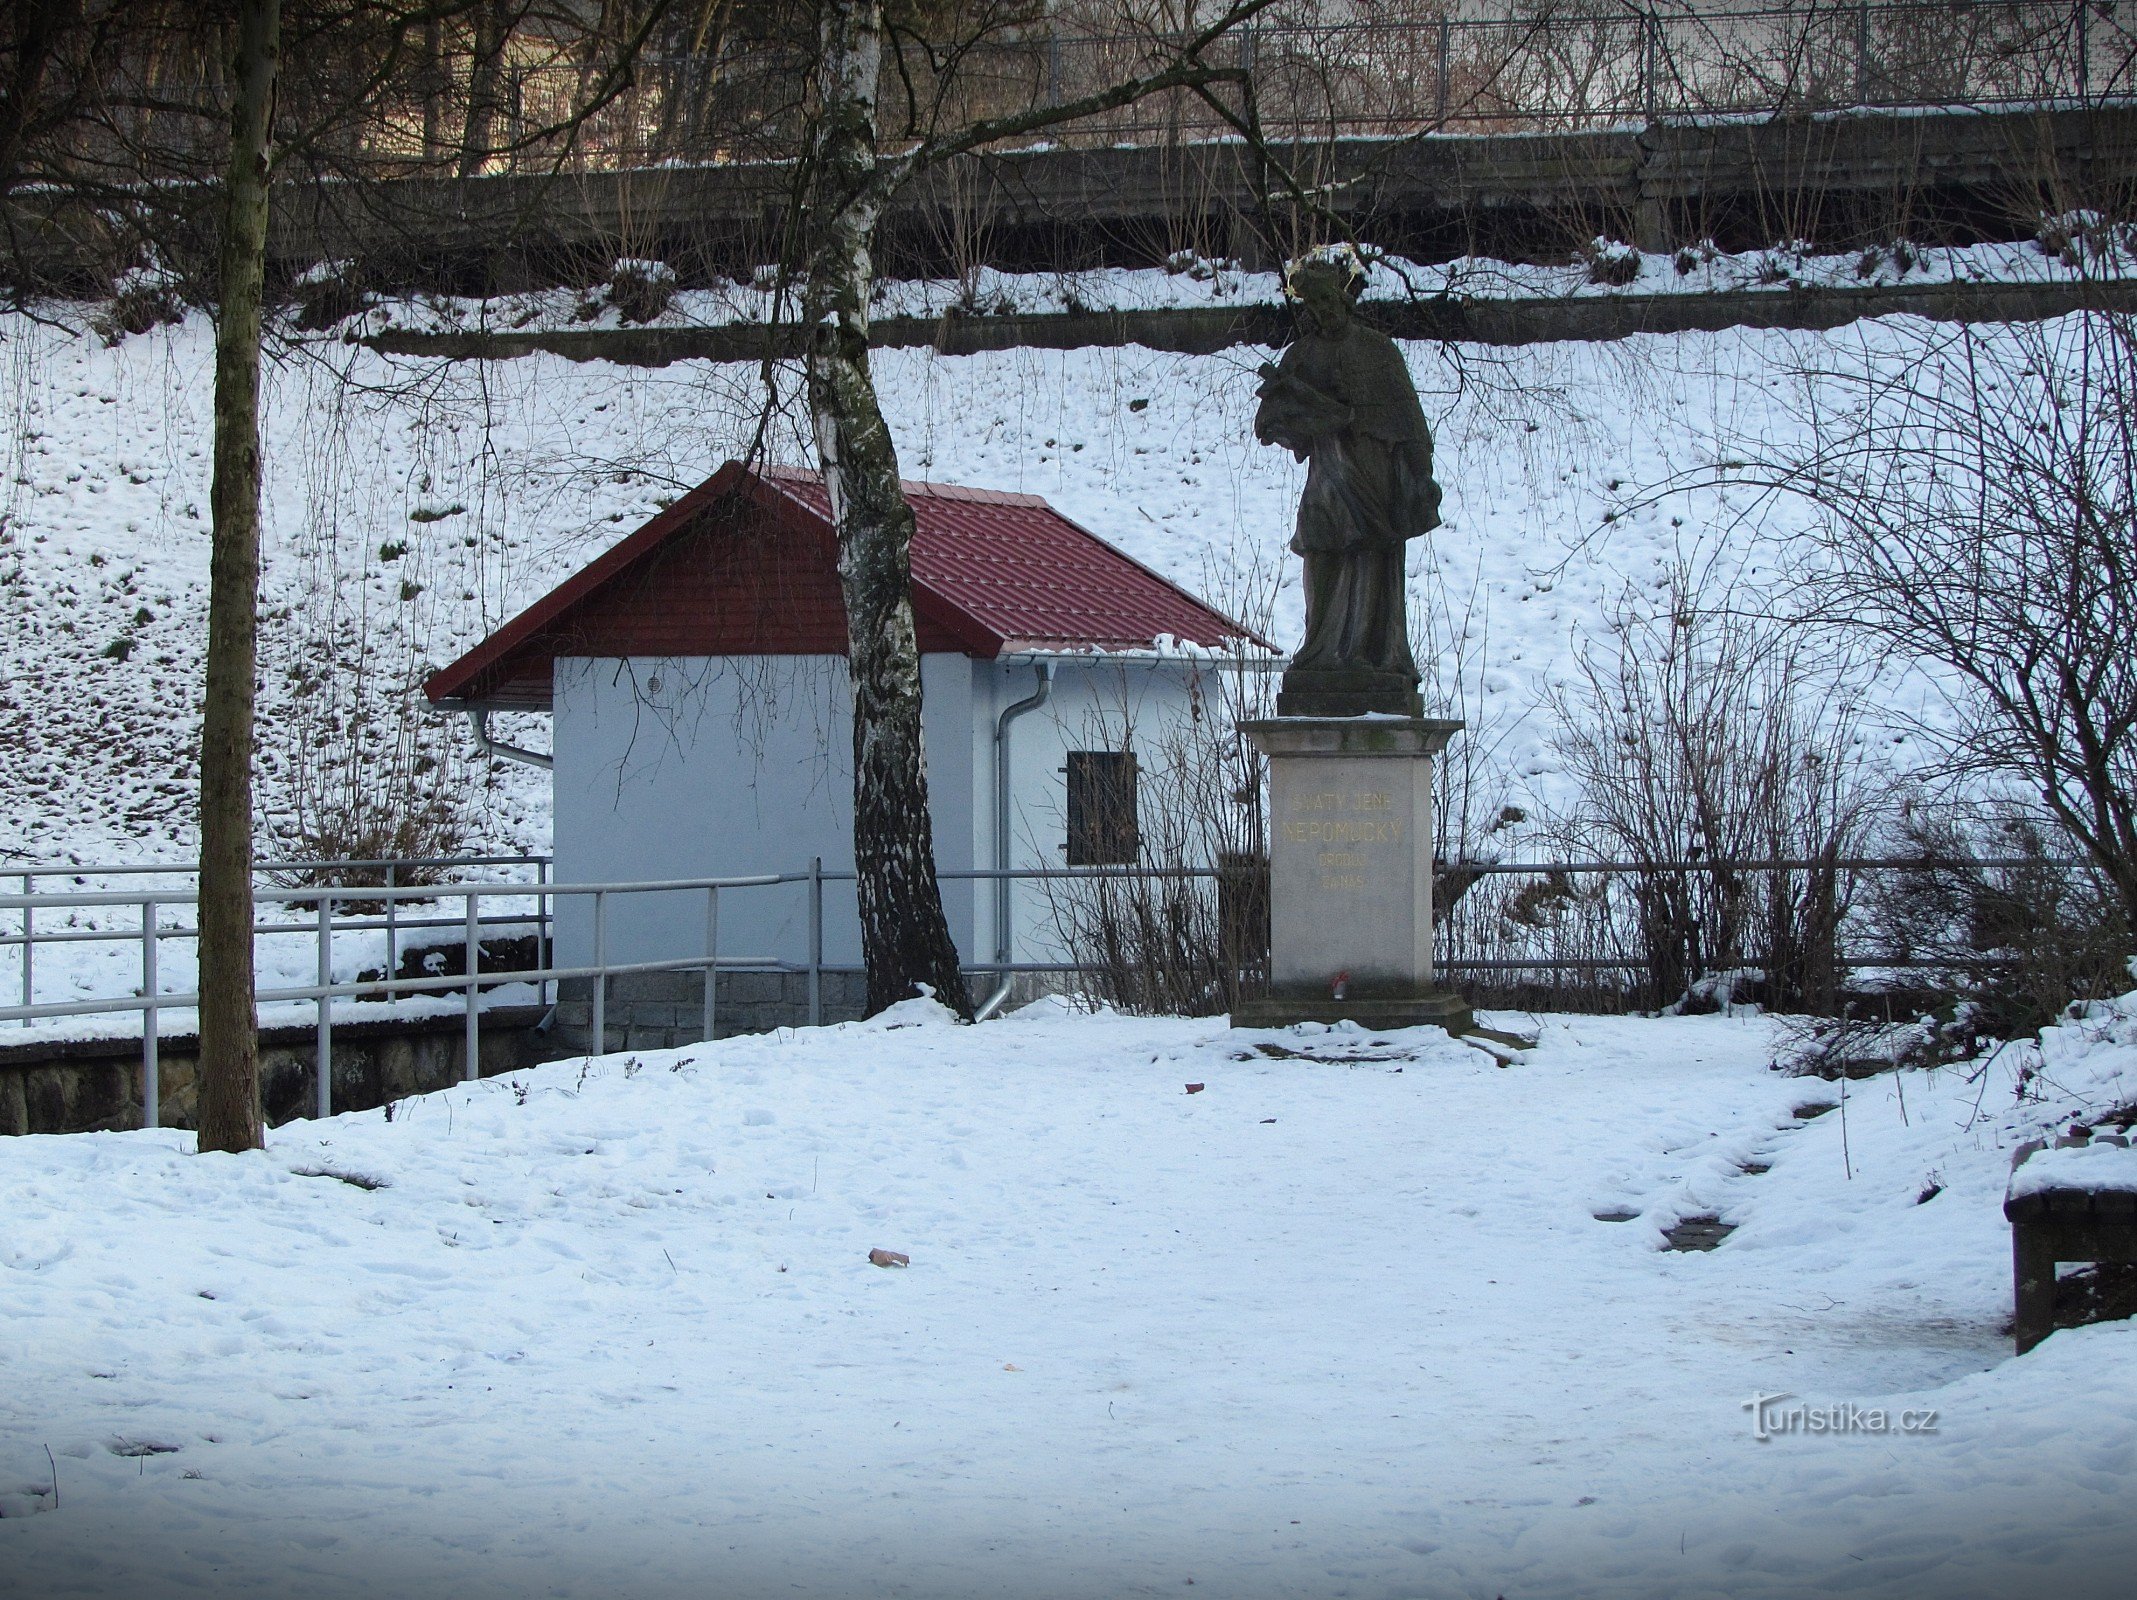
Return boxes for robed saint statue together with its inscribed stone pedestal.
[1233,246,1470,1032]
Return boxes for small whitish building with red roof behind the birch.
[425,464,1274,1029]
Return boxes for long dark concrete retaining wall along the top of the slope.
[0,103,2137,293]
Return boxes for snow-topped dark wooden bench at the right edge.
[2005,1134,2137,1354]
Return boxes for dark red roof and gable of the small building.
[423,461,1269,709]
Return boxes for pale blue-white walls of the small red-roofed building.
[553,654,1222,966]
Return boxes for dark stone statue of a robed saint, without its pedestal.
[1254,256,1440,716]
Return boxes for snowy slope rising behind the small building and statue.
[0,296,1957,875]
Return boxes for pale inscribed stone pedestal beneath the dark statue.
[1233,716,1472,1034]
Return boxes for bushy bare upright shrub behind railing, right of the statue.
[1556,572,1883,1010]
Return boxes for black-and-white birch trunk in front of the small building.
[804,0,972,1017]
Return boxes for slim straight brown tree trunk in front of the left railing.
[199,0,282,1149]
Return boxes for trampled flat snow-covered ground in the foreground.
[0,998,2137,1600]
